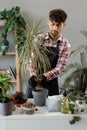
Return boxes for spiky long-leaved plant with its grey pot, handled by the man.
[18,19,50,106]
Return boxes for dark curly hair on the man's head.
[49,9,67,23]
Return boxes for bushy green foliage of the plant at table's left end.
[0,72,13,103]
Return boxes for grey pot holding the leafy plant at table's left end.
[0,101,13,116]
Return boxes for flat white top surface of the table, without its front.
[0,99,87,119]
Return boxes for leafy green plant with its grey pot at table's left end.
[0,72,13,116]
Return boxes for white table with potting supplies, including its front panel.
[0,103,87,130]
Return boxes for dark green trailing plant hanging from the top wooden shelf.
[0,6,26,55]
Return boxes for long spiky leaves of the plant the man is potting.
[16,18,50,75]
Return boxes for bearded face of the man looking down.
[48,20,65,37]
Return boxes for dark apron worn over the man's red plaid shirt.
[26,41,60,98]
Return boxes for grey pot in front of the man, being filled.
[32,88,48,106]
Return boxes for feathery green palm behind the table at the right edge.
[62,31,87,100]
